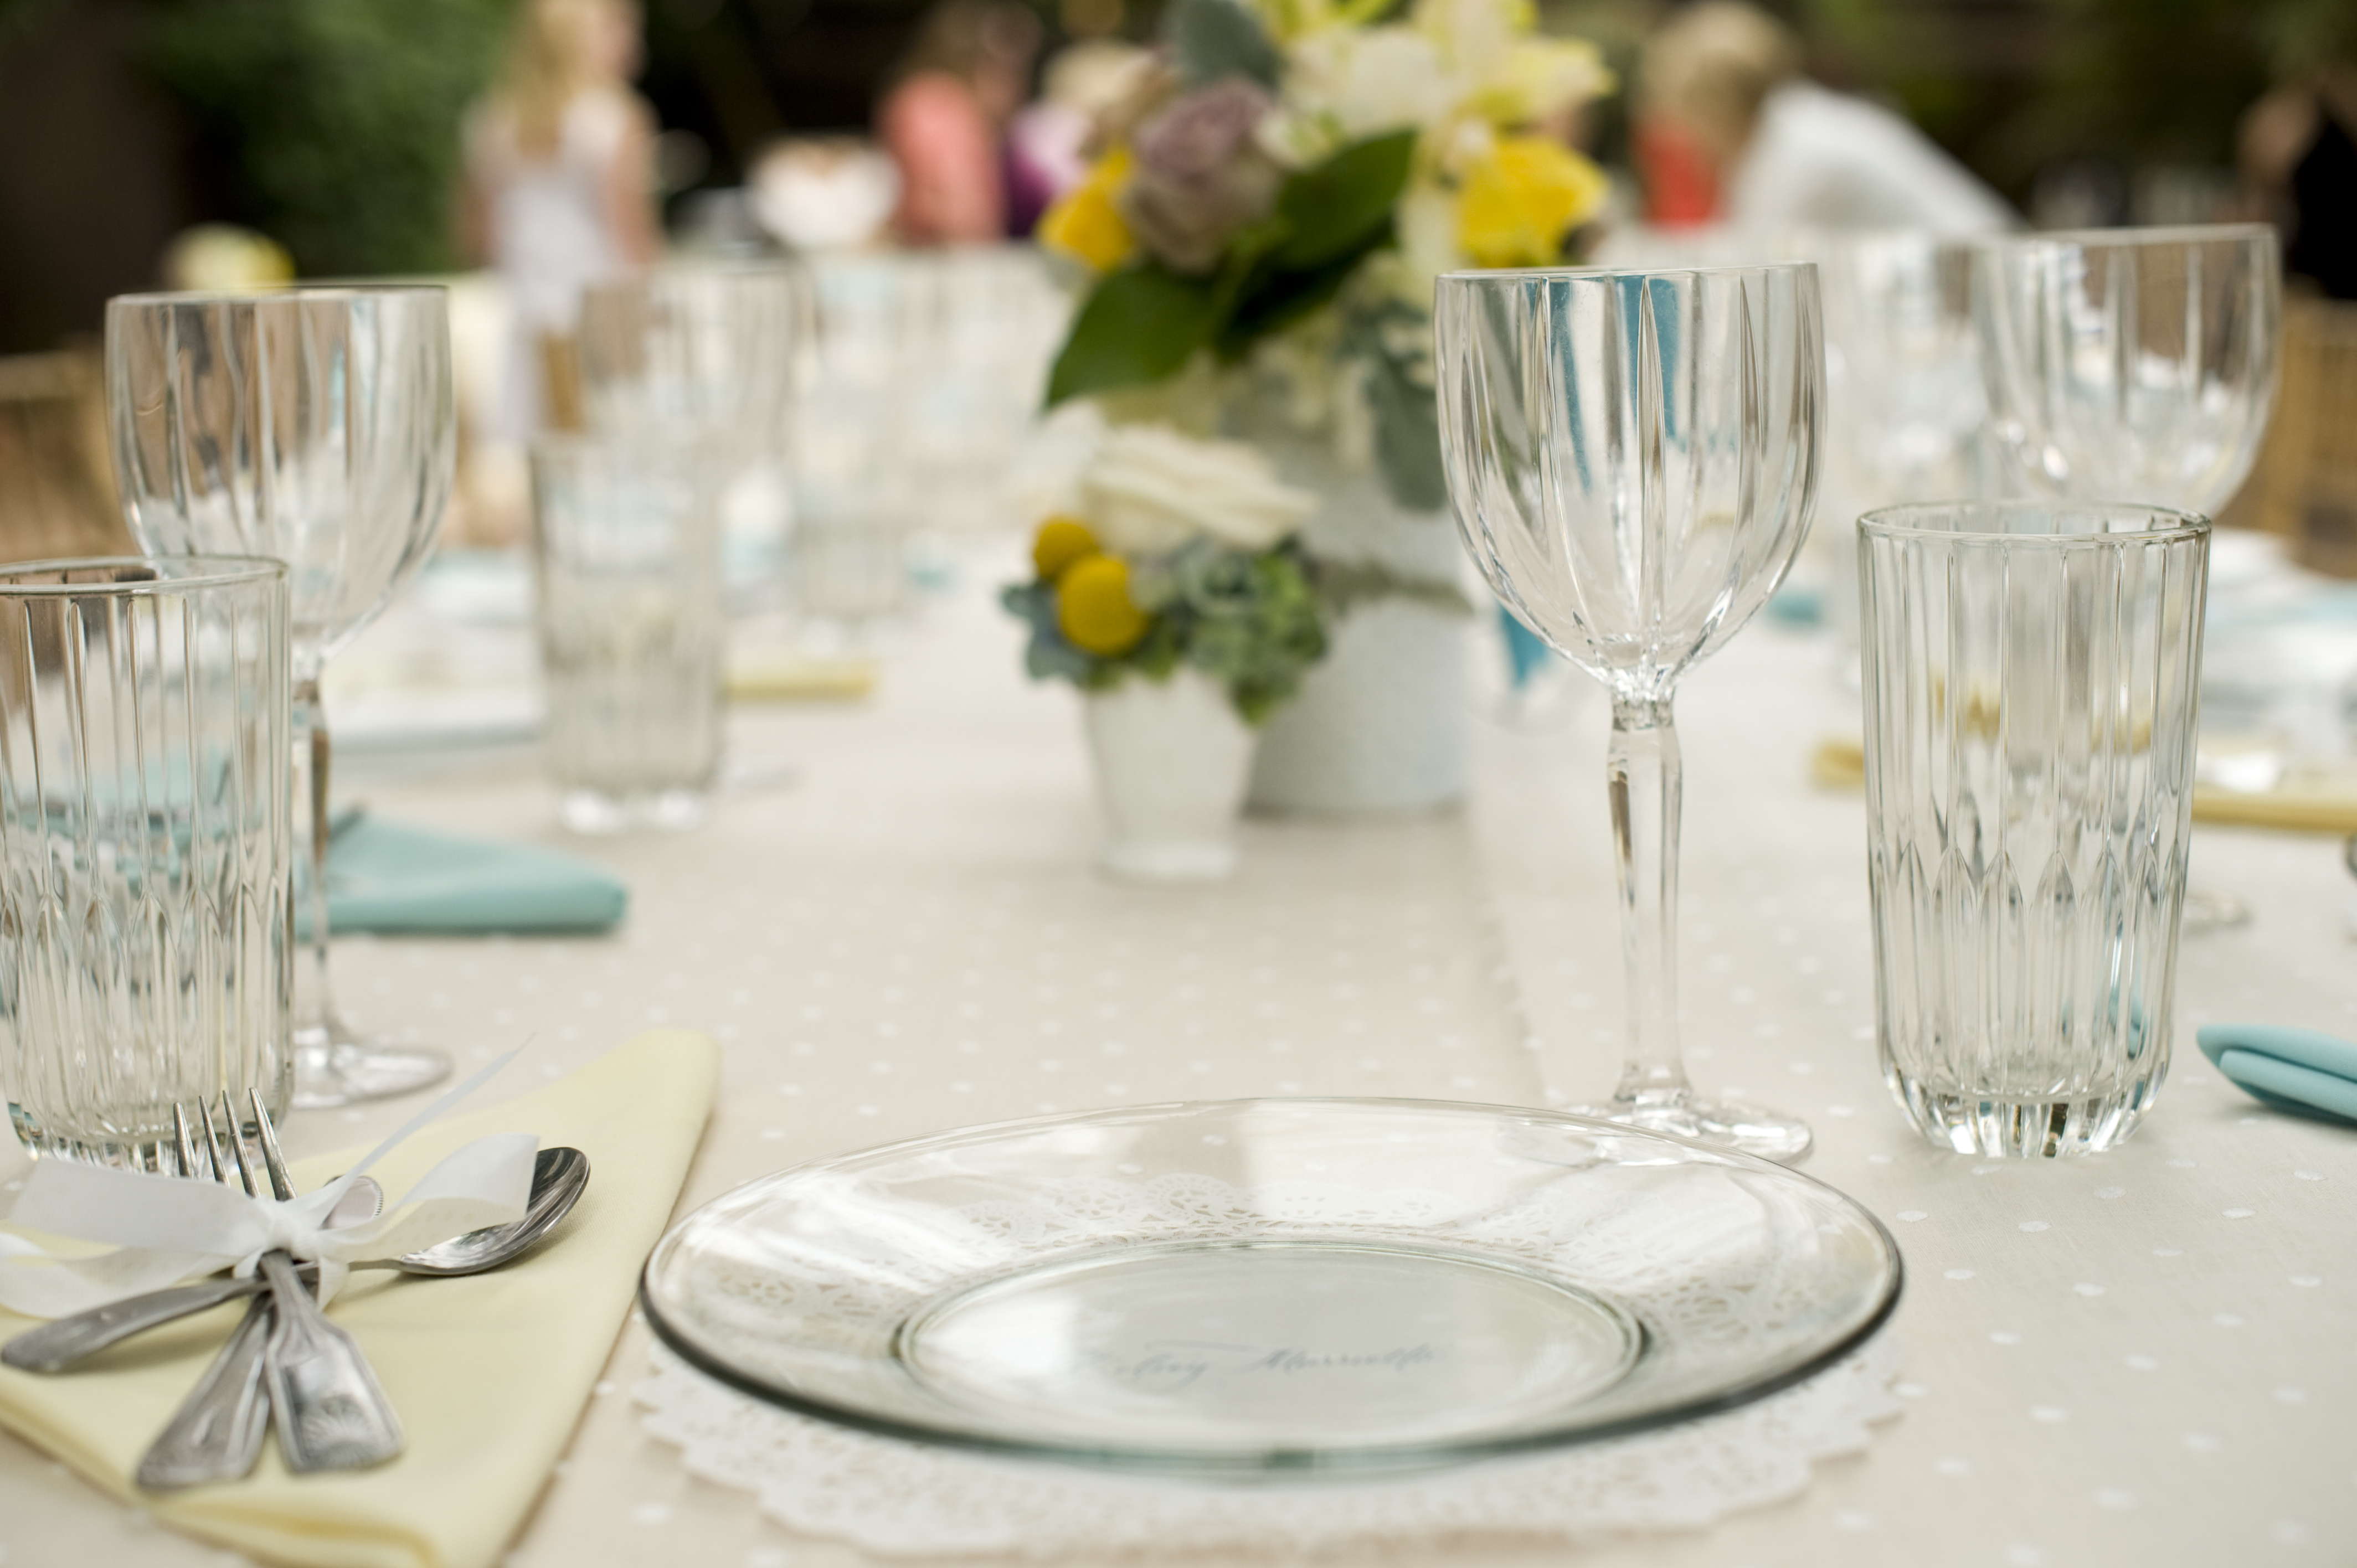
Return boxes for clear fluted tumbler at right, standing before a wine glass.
[1860,502,2209,1156]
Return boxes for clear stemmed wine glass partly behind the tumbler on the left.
[106,288,457,1108]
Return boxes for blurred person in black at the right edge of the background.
[2239,52,2357,300]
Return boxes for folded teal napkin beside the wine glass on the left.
[295,813,629,936]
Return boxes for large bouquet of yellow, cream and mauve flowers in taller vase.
[1039,0,1610,507]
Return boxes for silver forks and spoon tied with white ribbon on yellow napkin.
[0,1092,589,1490]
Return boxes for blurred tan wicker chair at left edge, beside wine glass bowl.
[0,352,139,561]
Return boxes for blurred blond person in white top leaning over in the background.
[1633,0,2015,234]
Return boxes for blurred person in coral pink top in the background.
[877,0,1039,245]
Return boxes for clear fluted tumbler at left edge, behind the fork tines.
[0,556,295,1165]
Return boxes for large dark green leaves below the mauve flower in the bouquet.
[1047,128,1417,408]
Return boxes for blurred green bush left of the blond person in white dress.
[144,0,512,276]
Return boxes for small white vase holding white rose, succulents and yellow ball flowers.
[1084,667,1256,882]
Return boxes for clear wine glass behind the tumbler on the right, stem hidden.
[1973,224,2282,931]
